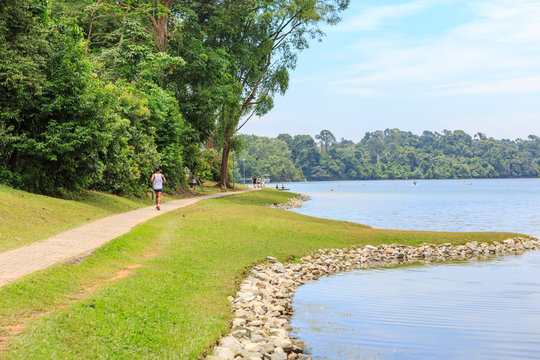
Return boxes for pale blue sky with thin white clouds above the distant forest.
[241,0,540,142]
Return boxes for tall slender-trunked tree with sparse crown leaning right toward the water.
[211,0,349,186]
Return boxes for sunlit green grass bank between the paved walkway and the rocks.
[0,190,512,359]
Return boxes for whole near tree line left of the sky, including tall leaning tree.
[0,0,349,195]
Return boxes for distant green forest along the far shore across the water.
[235,129,540,182]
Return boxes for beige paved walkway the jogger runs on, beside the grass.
[0,190,250,287]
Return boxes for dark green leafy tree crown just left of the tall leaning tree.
[167,0,232,143]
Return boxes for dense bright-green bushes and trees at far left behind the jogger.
[0,0,194,194]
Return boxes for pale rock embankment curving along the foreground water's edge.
[206,238,540,360]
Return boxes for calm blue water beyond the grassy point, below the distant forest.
[278,179,540,236]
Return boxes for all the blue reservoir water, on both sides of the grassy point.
[274,179,540,360]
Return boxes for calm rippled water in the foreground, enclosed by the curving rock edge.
[291,251,540,360]
